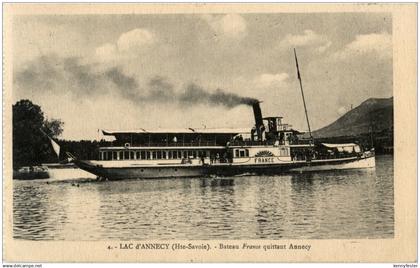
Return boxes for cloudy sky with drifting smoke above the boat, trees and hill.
[12,13,393,140]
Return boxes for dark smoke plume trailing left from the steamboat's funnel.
[14,56,258,108]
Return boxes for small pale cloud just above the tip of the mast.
[280,30,332,53]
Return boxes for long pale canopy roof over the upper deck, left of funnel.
[102,128,250,136]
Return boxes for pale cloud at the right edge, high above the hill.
[334,32,392,59]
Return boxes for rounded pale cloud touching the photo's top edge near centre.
[201,14,247,38]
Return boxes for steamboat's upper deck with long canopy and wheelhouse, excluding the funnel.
[97,122,309,149]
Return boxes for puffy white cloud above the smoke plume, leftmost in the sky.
[95,28,157,61]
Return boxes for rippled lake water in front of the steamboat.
[13,155,394,240]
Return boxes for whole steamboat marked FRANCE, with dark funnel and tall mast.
[67,52,375,180]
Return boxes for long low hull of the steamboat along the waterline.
[76,156,375,179]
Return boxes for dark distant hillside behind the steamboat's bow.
[313,97,394,138]
